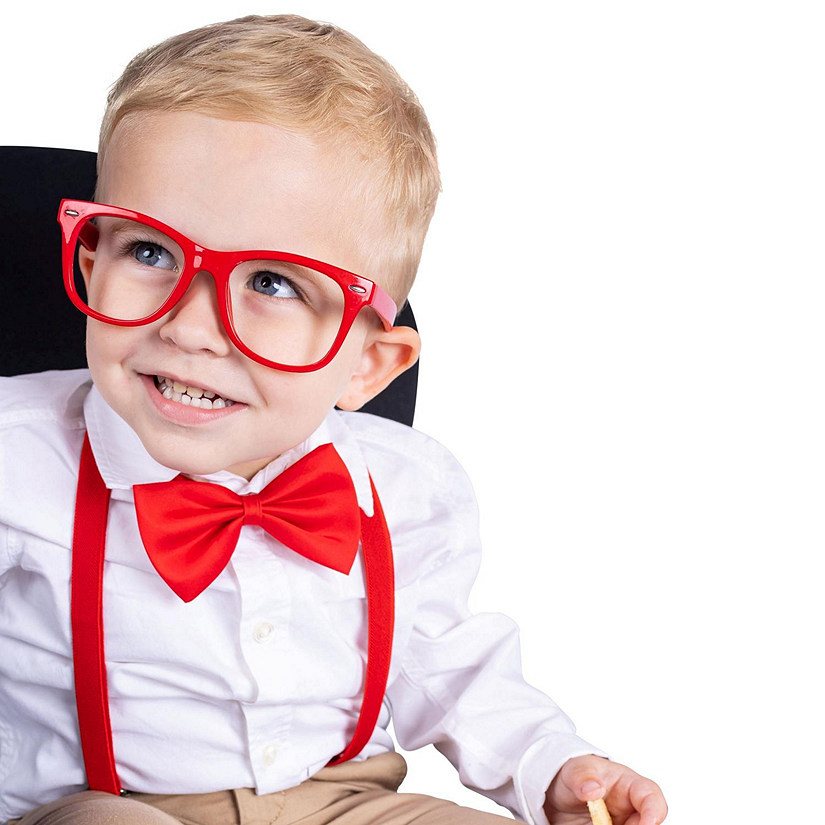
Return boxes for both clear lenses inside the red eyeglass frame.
[72,216,345,366]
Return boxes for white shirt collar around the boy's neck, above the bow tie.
[83,385,373,516]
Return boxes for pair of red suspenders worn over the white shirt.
[72,436,395,794]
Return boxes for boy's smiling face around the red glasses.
[87,112,417,478]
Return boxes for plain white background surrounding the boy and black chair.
[0,0,825,825]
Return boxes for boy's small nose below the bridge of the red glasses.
[159,271,232,355]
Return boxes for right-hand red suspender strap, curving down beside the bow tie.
[328,476,395,765]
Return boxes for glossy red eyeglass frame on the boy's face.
[57,198,398,372]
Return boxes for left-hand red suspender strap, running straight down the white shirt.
[72,436,120,794]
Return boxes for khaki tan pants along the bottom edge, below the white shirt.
[15,753,513,825]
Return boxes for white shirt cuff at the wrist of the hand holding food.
[513,733,609,825]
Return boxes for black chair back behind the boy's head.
[0,146,418,425]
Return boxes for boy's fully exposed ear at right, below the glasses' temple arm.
[337,327,421,410]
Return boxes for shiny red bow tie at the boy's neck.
[133,444,361,602]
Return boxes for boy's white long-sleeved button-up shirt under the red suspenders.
[0,370,598,825]
